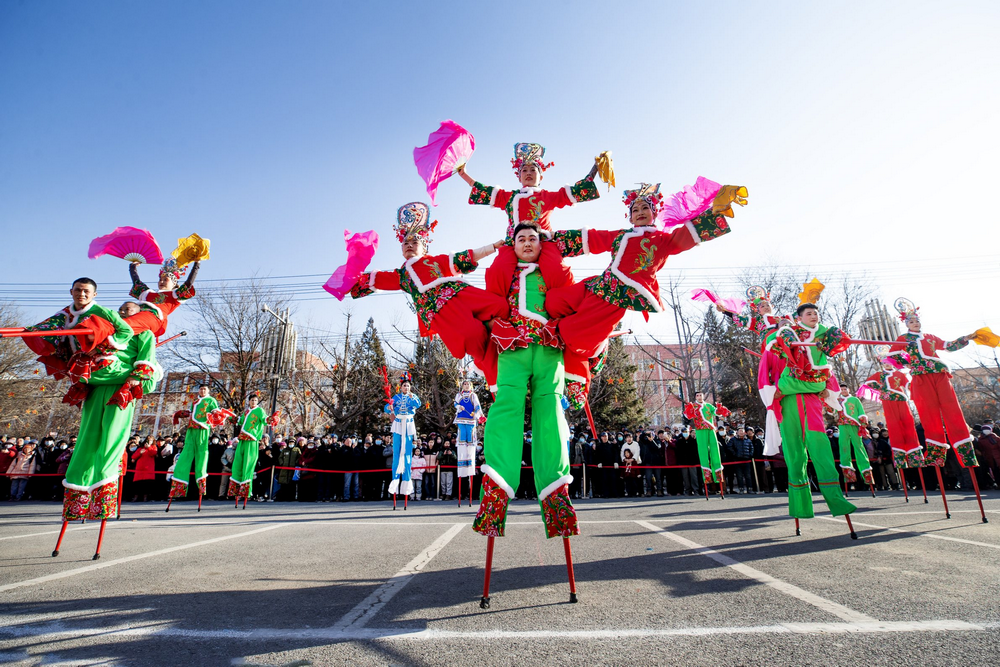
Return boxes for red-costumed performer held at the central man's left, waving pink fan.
[332,202,507,384]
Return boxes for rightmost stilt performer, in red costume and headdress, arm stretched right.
[889,298,988,523]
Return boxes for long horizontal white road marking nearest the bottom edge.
[0,619,984,644]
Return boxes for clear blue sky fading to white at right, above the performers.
[0,0,1000,366]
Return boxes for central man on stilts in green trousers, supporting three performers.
[472,223,580,608]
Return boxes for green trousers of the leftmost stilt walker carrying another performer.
[63,385,135,491]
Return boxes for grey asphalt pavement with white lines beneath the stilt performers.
[0,491,1000,667]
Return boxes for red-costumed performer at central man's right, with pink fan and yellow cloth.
[543,178,746,407]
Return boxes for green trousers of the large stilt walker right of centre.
[778,394,857,519]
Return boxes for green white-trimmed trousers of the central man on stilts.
[482,344,573,502]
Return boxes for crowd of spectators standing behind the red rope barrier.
[0,420,1000,502]
